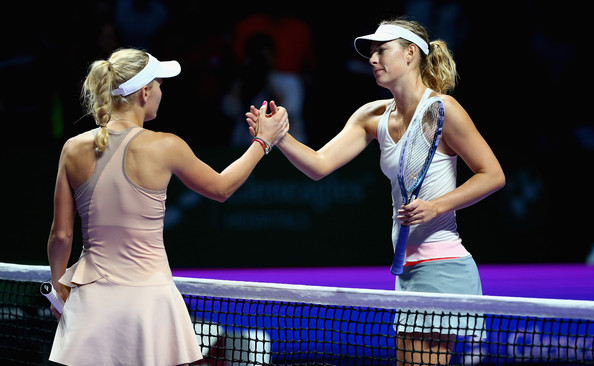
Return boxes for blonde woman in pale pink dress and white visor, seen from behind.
[48,49,288,366]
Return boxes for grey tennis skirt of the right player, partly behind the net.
[395,256,485,338]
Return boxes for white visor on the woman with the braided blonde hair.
[111,53,181,97]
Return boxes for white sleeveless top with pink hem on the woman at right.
[377,88,469,265]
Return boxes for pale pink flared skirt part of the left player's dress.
[50,279,202,366]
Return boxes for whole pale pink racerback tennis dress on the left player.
[50,127,202,366]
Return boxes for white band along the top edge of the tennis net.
[0,262,594,320]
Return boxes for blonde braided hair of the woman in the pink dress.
[82,49,148,152]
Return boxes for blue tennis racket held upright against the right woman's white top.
[390,97,444,276]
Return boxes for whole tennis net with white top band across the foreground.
[0,263,594,366]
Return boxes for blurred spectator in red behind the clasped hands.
[223,13,315,146]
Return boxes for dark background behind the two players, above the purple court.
[0,0,594,267]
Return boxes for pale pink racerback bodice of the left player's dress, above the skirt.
[60,127,173,287]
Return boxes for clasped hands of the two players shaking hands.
[246,101,289,146]
